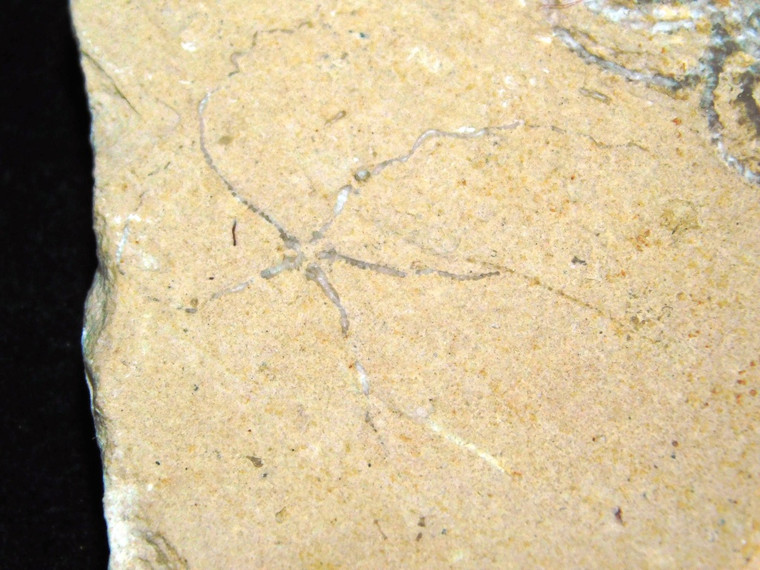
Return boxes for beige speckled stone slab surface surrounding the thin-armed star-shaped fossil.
[72,0,760,568]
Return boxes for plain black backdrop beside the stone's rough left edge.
[0,0,108,569]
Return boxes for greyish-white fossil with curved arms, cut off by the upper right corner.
[549,0,760,184]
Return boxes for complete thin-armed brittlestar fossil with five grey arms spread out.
[198,92,522,336]
